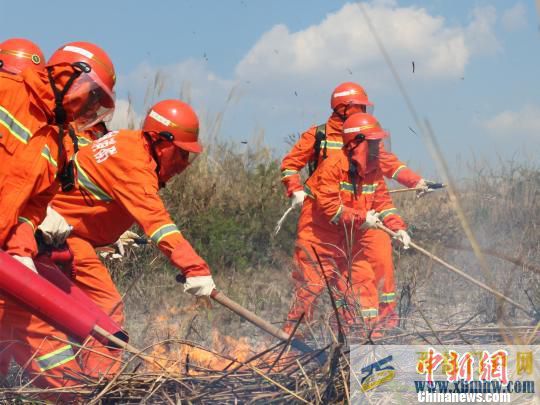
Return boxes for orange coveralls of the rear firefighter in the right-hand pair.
[281,113,416,326]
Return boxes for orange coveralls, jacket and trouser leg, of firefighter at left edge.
[0,67,83,392]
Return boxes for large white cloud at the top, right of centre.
[236,1,499,83]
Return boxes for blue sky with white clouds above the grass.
[0,0,540,173]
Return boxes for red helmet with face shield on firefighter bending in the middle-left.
[143,100,202,186]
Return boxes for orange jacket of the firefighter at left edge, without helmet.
[0,69,72,247]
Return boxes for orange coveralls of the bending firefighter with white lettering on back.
[2,130,210,385]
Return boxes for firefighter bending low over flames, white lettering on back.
[4,100,215,384]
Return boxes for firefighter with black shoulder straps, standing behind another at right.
[281,82,429,327]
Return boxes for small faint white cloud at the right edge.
[481,104,540,139]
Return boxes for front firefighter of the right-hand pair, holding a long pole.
[285,113,410,331]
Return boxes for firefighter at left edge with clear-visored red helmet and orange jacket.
[0,42,115,252]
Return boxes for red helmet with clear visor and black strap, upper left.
[47,42,116,131]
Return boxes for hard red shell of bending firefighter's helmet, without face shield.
[143,100,202,153]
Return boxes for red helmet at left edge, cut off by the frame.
[0,38,45,74]
